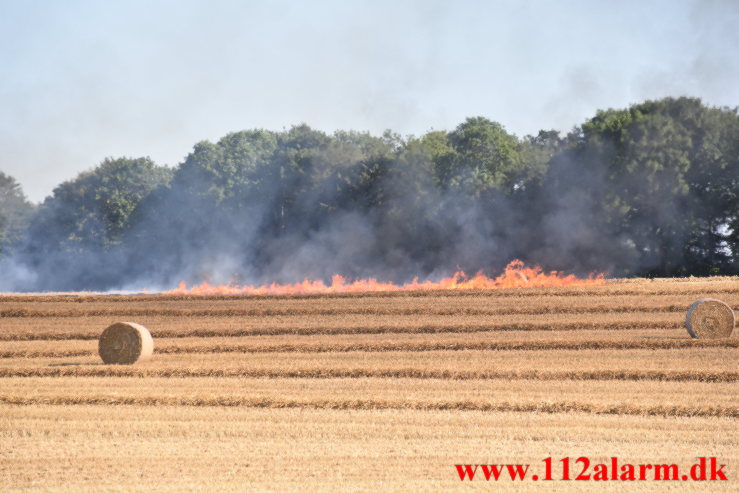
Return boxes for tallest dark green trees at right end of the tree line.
[580,98,739,275]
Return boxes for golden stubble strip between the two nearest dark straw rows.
[0,376,739,418]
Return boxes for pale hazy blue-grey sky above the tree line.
[0,0,739,202]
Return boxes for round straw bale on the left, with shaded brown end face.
[98,322,154,365]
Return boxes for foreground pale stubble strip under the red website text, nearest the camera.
[0,405,739,492]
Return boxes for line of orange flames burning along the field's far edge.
[164,260,605,295]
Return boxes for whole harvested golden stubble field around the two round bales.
[0,278,739,491]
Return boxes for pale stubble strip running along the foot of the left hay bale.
[0,348,739,373]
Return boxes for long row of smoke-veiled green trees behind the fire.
[0,98,739,291]
